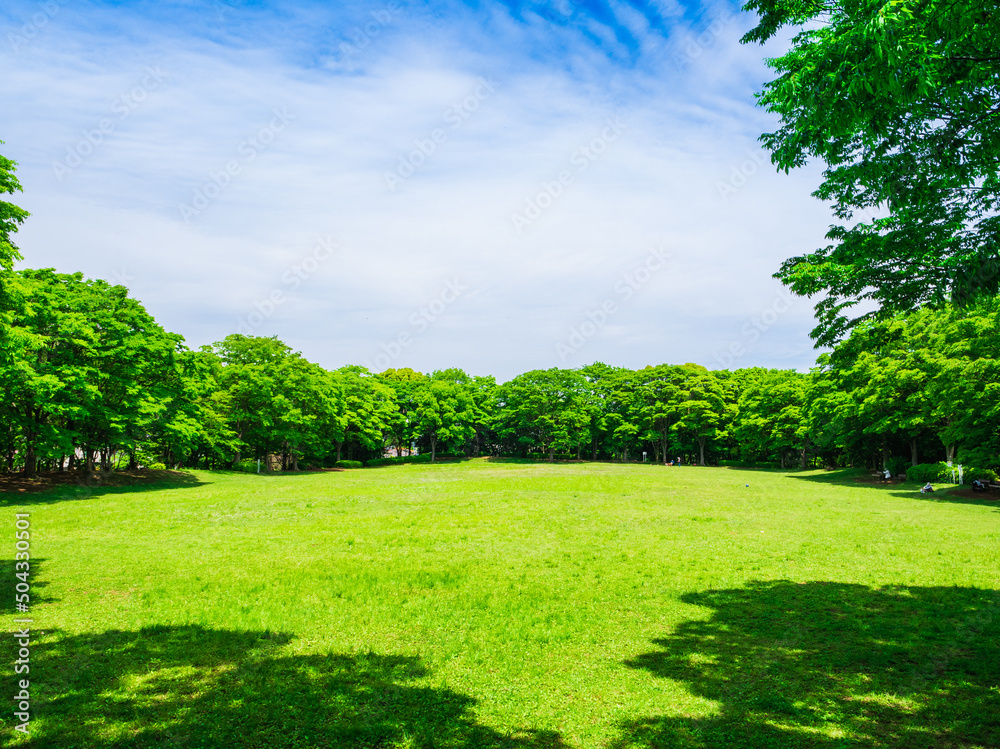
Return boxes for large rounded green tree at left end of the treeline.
[0,270,182,475]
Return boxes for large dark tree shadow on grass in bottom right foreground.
[613,581,1000,749]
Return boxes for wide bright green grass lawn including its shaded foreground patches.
[0,460,1000,749]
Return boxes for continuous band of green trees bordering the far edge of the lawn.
[0,270,1000,474]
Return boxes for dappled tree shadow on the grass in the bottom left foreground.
[4,626,565,749]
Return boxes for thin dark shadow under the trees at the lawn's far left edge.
[0,471,205,507]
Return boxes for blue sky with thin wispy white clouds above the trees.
[0,0,831,379]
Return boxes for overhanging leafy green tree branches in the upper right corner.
[743,0,1000,345]
